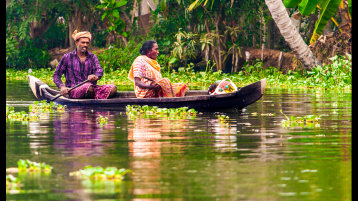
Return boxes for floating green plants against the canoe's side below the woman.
[126,105,198,119]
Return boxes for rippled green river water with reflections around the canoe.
[6,81,352,201]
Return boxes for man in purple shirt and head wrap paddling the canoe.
[53,30,117,99]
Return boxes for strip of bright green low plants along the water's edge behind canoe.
[6,54,352,90]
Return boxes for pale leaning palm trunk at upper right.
[265,0,320,69]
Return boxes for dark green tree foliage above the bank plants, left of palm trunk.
[6,0,283,70]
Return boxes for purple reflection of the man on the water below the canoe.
[53,108,115,156]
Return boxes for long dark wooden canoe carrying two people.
[28,75,266,109]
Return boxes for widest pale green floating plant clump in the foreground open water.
[70,165,132,181]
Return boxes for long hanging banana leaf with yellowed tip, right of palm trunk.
[310,0,341,44]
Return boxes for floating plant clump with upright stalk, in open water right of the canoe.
[280,109,321,127]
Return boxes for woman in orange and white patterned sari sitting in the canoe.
[128,40,189,98]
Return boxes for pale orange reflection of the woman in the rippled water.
[128,118,189,200]
